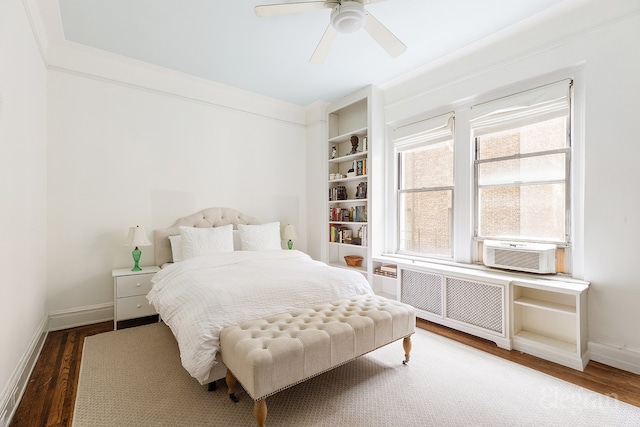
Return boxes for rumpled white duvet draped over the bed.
[147,250,373,384]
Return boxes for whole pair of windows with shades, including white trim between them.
[381,79,583,277]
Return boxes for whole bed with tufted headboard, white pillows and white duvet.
[147,208,373,384]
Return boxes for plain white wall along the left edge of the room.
[0,0,47,425]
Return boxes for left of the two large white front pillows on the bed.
[179,224,233,259]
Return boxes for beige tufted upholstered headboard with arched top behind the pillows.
[153,208,259,266]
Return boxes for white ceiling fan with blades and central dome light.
[254,0,407,64]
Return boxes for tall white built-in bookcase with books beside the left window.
[324,87,382,281]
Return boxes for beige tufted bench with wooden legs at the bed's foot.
[220,295,416,426]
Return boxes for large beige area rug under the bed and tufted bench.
[73,323,640,427]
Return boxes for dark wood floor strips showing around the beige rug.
[10,319,640,427]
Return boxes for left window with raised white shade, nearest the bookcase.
[394,114,454,258]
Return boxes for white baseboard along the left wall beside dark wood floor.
[0,316,48,427]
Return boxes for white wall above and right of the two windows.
[384,0,640,373]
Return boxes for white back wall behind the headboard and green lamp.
[47,67,306,315]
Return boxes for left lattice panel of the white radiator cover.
[400,270,442,316]
